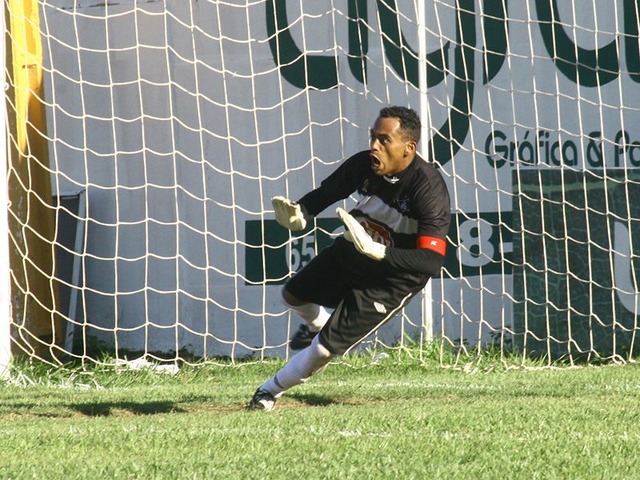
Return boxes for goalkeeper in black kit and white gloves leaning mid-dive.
[248,106,451,410]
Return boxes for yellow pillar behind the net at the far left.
[4,0,62,361]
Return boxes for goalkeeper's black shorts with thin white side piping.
[285,237,428,355]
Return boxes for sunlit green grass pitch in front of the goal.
[0,359,640,479]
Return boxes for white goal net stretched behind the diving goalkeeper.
[5,0,640,368]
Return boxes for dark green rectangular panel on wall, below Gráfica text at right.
[513,169,640,359]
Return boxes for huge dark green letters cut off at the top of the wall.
[265,0,640,165]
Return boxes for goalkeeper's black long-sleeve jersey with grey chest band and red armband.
[299,150,451,275]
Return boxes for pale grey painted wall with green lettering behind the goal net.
[37,0,640,356]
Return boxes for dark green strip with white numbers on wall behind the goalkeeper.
[245,212,512,285]
